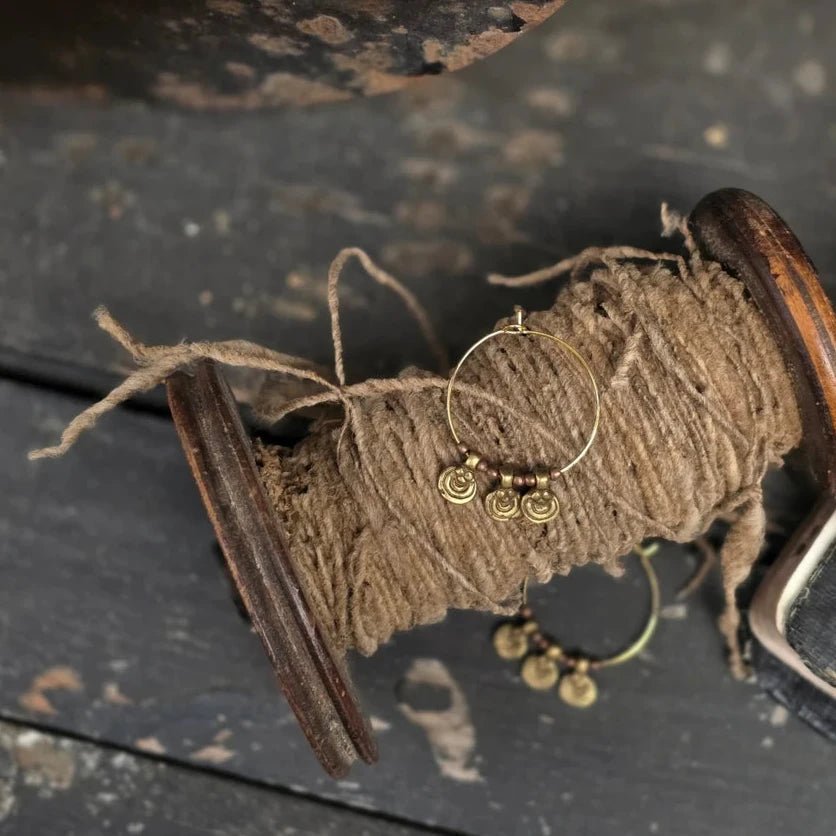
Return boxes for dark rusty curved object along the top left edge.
[0,0,564,110]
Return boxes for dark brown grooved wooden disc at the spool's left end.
[167,361,377,778]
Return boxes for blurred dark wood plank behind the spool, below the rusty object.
[0,0,836,396]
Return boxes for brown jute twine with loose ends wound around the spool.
[30,208,801,674]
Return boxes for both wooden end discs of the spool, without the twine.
[167,189,836,777]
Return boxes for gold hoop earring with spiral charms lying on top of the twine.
[438,306,601,524]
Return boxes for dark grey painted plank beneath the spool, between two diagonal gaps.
[0,382,836,836]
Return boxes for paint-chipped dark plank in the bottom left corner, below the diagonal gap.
[0,721,428,836]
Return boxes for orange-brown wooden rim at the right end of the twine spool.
[688,189,836,494]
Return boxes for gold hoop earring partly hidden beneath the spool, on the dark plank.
[493,543,661,708]
